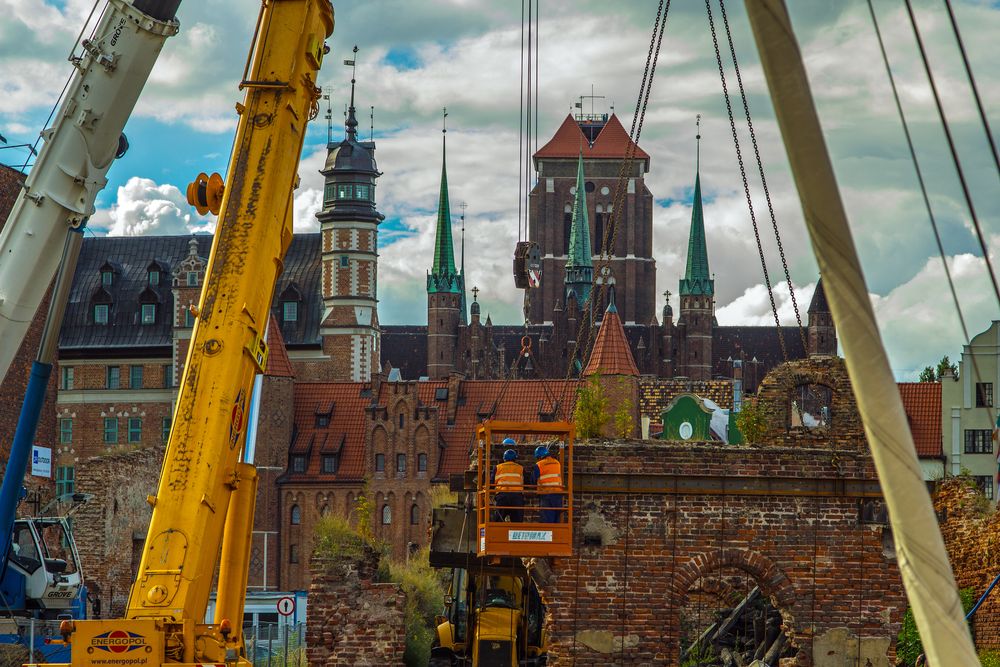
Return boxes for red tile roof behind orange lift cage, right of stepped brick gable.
[436,380,580,479]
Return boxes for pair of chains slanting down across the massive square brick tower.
[566,0,670,380]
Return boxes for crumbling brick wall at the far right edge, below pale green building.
[934,477,1000,650]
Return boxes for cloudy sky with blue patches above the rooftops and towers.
[0,0,1000,380]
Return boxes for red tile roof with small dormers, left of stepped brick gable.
[285,382,372,482]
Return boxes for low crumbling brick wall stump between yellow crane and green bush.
[306,550,406,667]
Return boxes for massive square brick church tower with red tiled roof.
[527,114,656,325]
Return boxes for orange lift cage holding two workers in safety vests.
[476,420,576,556]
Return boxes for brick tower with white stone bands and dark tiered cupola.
[316,79,384,382]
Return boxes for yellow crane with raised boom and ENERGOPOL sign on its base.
[34,0,334,667]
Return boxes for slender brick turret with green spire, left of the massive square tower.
[427,122,465,380]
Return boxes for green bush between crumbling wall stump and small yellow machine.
[388,548,444,667]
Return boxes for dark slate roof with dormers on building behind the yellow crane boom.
[59,234,323,356]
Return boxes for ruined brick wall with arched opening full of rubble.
[541,442,905,666]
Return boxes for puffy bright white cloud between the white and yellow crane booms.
[100,177,215,236]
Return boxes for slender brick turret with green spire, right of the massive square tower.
[674,152,715,380]
